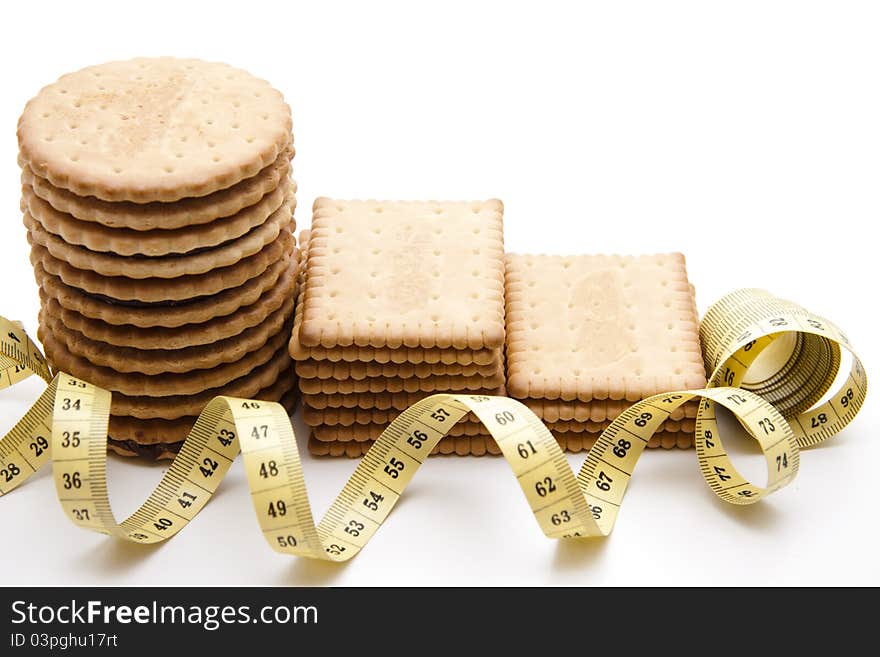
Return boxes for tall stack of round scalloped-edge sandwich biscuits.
[18,58,298,457]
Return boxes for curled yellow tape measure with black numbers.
[0,290,867,561]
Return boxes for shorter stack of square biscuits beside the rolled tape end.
[505,253,706,451]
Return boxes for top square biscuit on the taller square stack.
[298,198,504,350]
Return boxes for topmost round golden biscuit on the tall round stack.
[18,57,292,203]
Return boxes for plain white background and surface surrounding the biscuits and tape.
[0,0,880,585]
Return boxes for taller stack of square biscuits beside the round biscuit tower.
[290,198,504,456]
